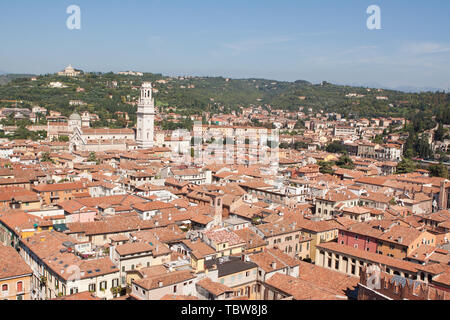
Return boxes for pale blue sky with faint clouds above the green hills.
[0,0,450,89]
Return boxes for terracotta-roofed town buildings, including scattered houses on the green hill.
[0,68,450,300]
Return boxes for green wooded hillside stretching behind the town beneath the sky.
[0,73,450,127]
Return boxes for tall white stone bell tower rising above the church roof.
[136,82,155,149]
